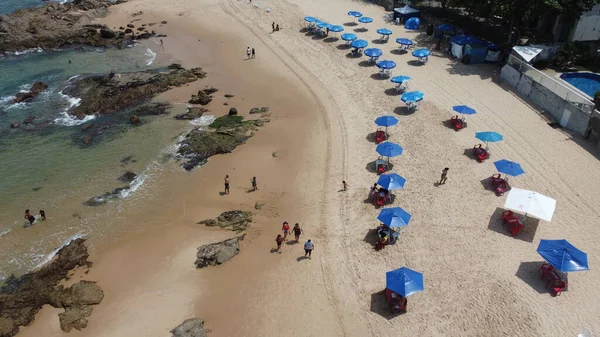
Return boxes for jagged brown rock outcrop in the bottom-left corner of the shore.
[0,239,104,337]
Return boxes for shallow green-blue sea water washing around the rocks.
[0,0,202,283]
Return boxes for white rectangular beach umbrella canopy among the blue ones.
[504,188,556,222]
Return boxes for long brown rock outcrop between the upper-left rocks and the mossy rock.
[63,68,206,118]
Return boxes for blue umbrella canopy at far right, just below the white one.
[537,240,590,273]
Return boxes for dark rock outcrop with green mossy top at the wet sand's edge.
[178,116,269,171]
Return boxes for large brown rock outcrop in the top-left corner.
[0,0,152,53]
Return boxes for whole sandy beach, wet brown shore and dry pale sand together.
[12,0,600,337]
